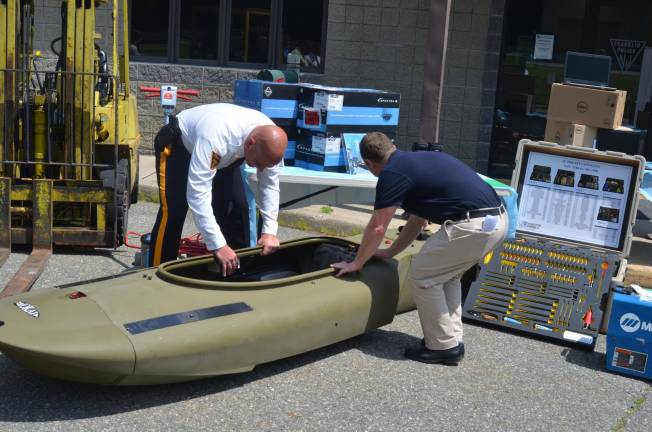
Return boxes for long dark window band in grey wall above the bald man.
[130,0,328,72]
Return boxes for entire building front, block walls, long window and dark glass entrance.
[35,0,652,178]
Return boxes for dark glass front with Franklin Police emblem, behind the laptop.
[489,0,652,179]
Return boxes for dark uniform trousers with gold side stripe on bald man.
[148,118,249,266]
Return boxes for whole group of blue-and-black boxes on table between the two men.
[234,80,400,172]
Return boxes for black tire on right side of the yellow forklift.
[100,159,131,247]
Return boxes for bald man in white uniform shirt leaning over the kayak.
[149,103,287,276]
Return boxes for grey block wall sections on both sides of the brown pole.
[324,0,505,172]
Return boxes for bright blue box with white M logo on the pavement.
[605,293,652,380]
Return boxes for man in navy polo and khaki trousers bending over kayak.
[332,132,508,365]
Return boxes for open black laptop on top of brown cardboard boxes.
[564,51,611,87]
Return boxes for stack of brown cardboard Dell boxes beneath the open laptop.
[545,83,627,148]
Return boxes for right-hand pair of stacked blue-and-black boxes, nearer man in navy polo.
[295,84,401,172]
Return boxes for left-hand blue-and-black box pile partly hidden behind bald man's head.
[233,80,299,165]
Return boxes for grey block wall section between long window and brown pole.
[324,0,430,154]
